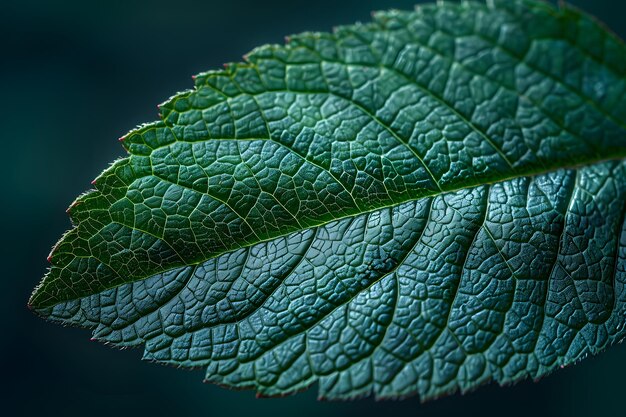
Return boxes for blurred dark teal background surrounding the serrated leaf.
[0,0,626,417]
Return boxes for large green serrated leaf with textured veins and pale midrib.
[29,0,626,399]
